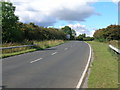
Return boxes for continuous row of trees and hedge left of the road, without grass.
[0,1,76,43]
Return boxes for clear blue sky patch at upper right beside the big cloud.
[81,2,118,28]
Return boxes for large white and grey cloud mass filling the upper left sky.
[12,0,98,26]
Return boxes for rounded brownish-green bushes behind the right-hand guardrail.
[93,25,120,42]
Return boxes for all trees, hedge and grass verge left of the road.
[0,1,76,57]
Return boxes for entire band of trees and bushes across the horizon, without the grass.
[3,1,120,43]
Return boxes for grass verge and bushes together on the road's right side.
[88,25,120,88]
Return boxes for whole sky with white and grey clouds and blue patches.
[10,0,118,36]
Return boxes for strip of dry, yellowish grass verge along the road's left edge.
[0,40,66,58]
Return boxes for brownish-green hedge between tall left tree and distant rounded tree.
[18,23,66,40]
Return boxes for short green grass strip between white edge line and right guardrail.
[87,41,118,88]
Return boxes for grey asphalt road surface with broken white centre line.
[2,41,90,88]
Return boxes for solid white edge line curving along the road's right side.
[76,42,91,90]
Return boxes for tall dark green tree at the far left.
[0,1,22,42]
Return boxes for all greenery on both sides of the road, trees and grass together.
[0,1,120,88]
